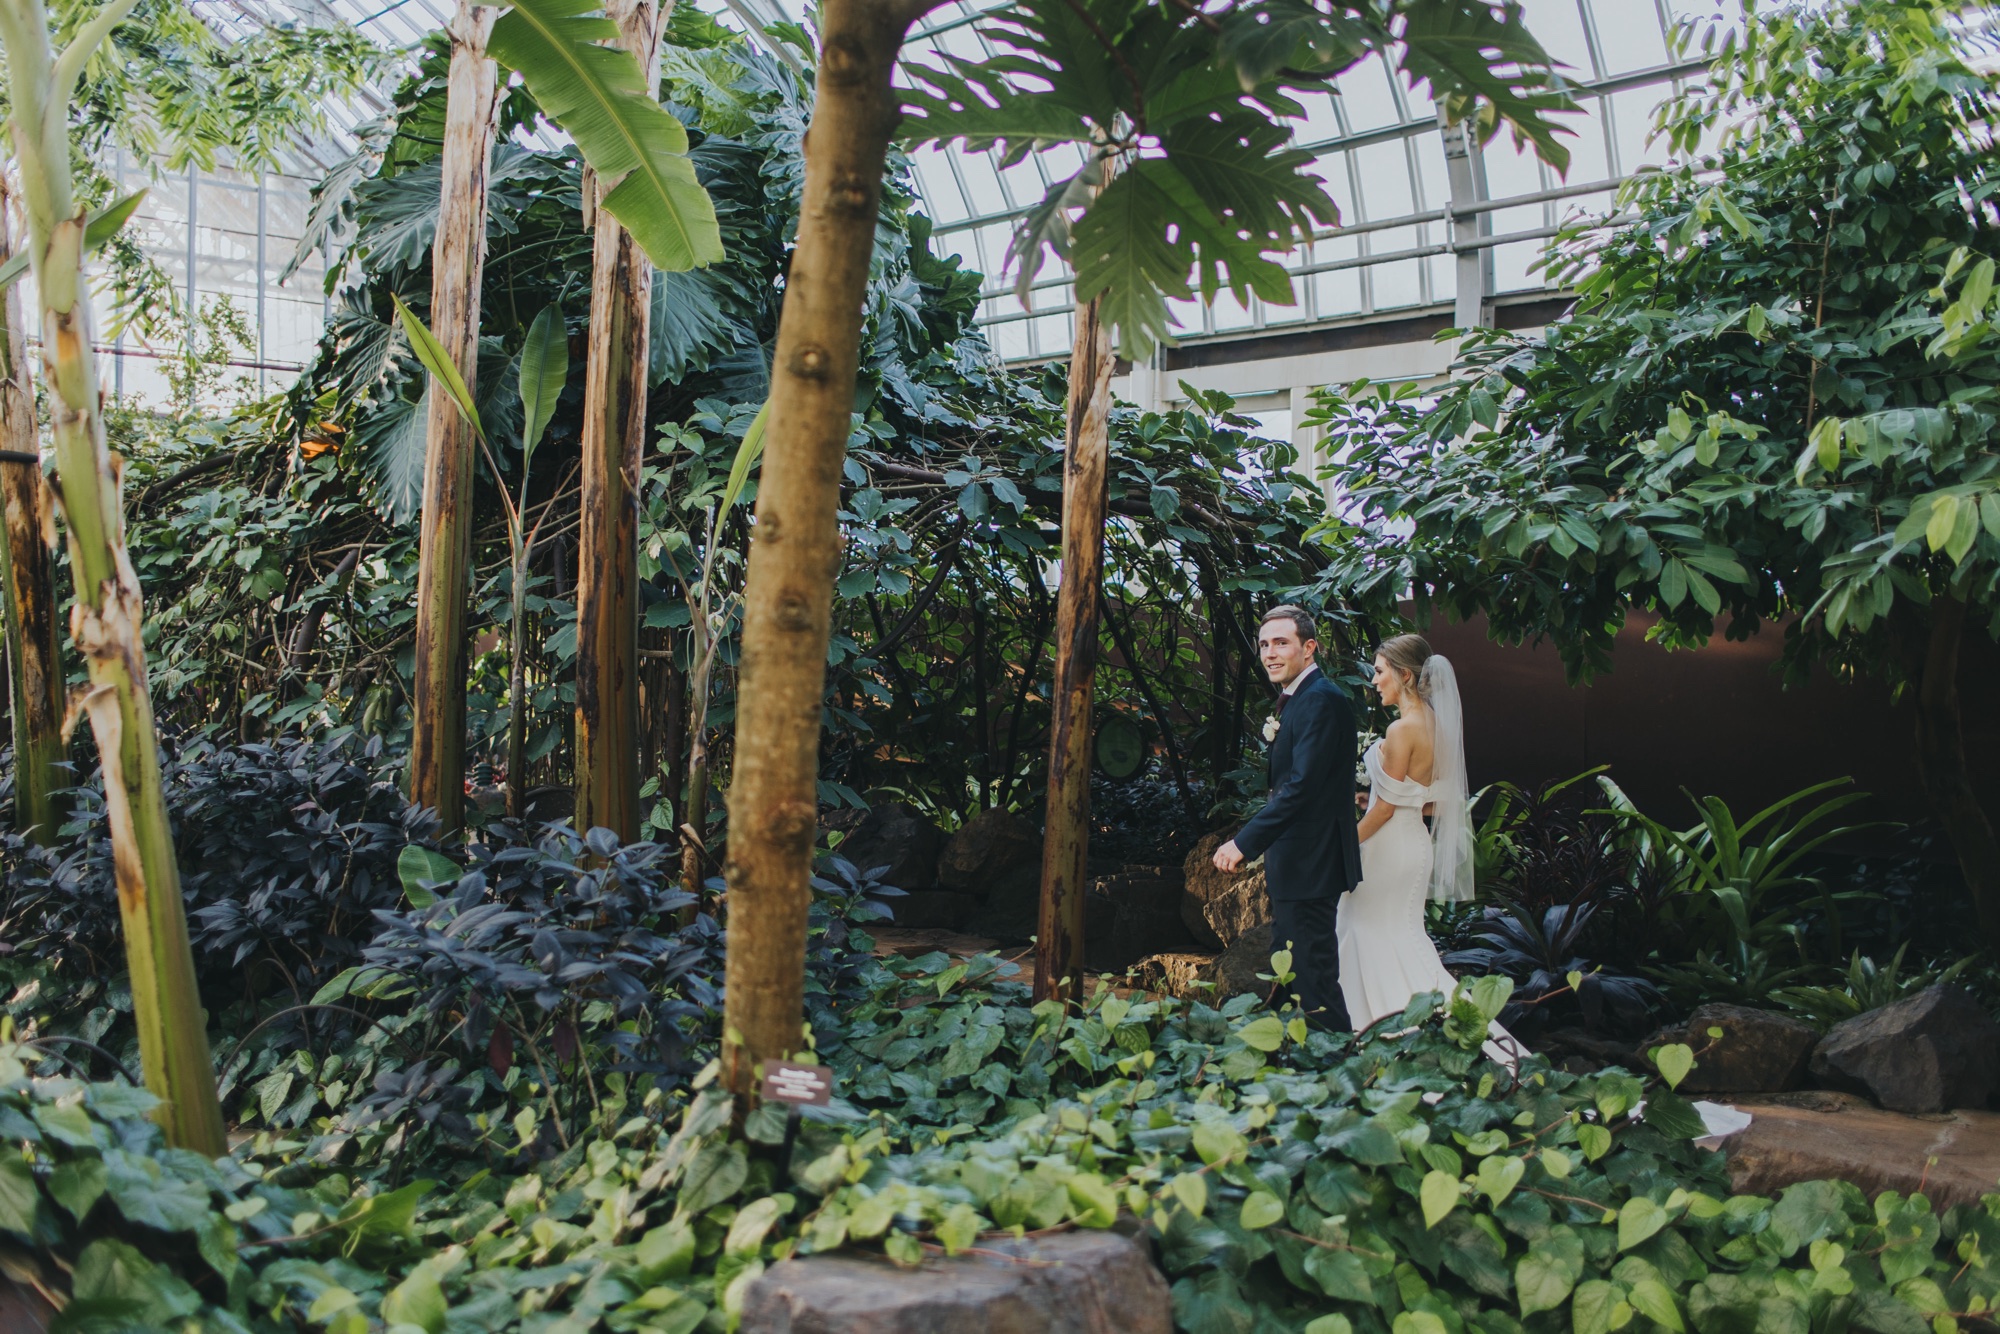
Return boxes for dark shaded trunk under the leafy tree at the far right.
[1916,594,2000,946]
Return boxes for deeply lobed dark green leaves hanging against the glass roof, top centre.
[904,0,1570,358]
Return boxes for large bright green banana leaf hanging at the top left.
[488,0,722,270]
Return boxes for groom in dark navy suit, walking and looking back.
[1214,606,1362,1030]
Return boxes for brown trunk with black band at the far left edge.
[0,172,70,846]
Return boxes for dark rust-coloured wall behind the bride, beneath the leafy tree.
[1426,616,2000,824]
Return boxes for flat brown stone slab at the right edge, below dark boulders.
[1722,1090,2000,1212]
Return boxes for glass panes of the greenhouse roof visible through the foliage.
[129,0,1722,408]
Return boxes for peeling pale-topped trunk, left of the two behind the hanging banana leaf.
[410,0,500,836]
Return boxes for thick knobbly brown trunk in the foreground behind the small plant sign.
[722,0,924,1110]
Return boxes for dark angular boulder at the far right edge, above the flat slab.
[1812,984,2000,1112]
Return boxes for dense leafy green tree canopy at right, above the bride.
[1316,0,2000,678]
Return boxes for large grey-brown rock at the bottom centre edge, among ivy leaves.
[742,1230,1174,1334]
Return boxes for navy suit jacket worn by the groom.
[1236,672,1362,900]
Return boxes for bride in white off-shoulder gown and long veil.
[1336,634,1524,1066]
